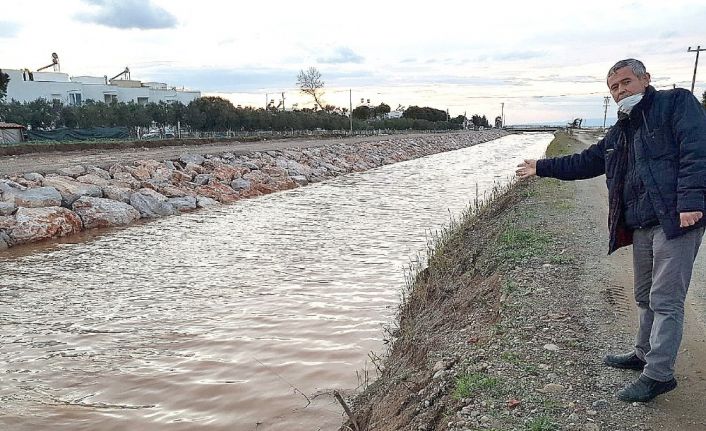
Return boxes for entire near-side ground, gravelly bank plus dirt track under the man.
[341,132,706,431]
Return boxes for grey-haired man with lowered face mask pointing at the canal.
[517,59,706,402]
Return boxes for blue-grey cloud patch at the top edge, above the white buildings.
[77,0,177,30]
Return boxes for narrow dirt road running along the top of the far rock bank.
[0,132,460,177]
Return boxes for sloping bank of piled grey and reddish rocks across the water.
[0,130,505,250]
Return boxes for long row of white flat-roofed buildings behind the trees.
[2,69,201,105]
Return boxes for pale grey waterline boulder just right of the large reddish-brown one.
[72,196,140,229]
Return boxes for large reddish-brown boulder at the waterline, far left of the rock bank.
[7,207,82,245]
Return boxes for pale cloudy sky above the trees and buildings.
[0,0,706,124]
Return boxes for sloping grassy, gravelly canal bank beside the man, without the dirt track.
[341,134,647,431]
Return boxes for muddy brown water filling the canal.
[0,134,551,431]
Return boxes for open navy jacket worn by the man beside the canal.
[537,86,706,253]
